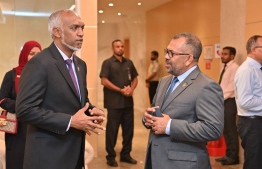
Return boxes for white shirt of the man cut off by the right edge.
[234,57,262,116]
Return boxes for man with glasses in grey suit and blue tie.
[143,33,224,169]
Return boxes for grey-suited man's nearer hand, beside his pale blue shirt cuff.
[151,114,170,134]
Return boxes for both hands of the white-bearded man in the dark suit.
[70,103,106,136]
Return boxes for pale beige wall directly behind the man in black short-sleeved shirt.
[98,14,148,114]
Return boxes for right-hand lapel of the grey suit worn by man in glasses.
[161,67,200,112]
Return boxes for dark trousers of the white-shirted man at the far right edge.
[237,116,262,169]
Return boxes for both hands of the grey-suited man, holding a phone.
[144,106,170,134]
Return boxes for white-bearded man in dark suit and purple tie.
[16,10,105,169]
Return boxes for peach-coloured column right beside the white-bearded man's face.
[75,0,98,157]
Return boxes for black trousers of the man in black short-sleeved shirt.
[106,107,134,160]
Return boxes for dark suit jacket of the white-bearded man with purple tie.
[16,43,93,169]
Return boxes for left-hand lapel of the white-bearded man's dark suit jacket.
[49,43,79,100]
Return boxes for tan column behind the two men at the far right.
[220,0,246,163]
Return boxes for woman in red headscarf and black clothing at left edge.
[0,40,42,169]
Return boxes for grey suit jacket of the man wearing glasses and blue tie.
[145,67,224,169]
